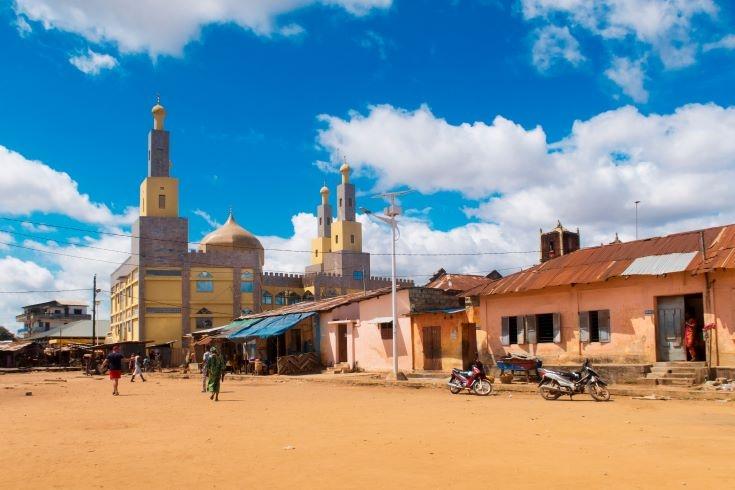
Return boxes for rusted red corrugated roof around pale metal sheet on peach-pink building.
[462,225,735,296]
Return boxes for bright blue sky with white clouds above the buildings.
[0,0,735,330]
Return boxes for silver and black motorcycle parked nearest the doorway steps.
[538,359,610,402]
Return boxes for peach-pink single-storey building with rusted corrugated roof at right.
[465,225,735,378]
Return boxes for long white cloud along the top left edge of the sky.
[15,0,392,56]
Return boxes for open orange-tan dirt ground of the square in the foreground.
[0,373,735,489]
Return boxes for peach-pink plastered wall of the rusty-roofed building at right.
[480,272,735,365]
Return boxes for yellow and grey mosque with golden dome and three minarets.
[110,101,403,347]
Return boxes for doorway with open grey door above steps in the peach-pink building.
[656,294,704,361]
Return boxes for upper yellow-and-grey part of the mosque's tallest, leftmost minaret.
[140,99,179,218]
